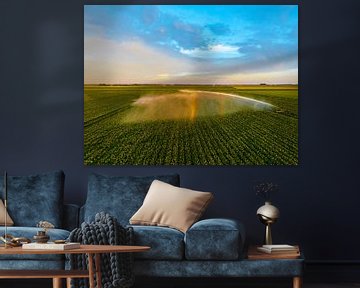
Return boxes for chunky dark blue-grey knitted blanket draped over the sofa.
[68,212,134,288]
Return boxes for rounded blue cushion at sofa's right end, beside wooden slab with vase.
[185,218,245,260]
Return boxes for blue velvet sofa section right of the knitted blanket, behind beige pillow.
[80,174,303,287]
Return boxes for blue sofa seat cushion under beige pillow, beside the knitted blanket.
[131,225,184,260]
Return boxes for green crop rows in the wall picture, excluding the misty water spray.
[84,87,298,165]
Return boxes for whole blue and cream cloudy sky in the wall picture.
[84,5,298,84]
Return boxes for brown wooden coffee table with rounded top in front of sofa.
[0,245,150,288]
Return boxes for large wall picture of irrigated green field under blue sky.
[84,5,299,166]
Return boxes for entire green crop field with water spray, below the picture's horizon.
[84,85,298,165]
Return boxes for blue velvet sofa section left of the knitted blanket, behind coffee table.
[0,171,79,270]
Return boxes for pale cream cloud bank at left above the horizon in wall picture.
[84,37,194,84]
